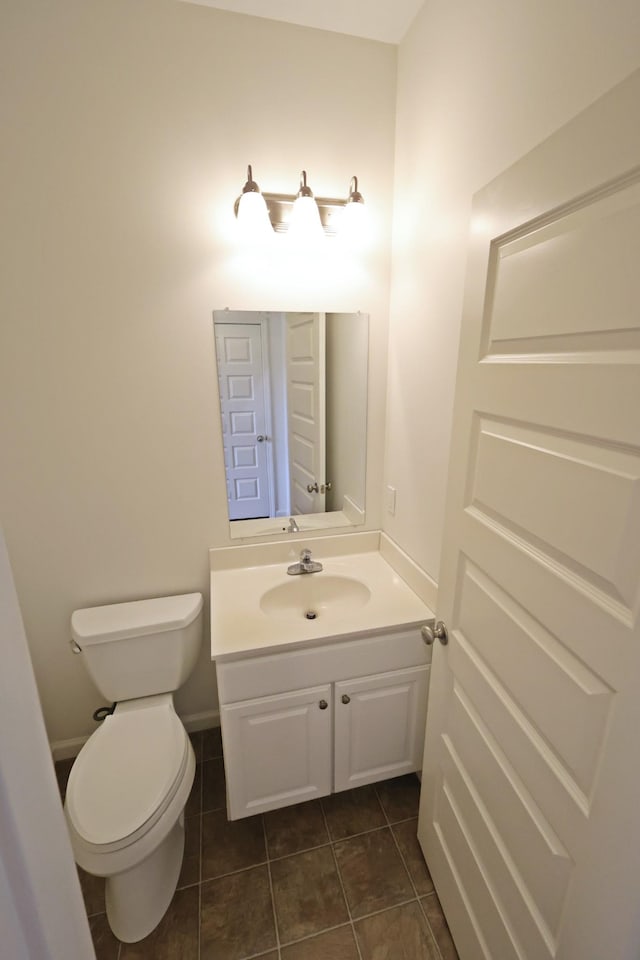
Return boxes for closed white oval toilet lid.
[66,704,189,844]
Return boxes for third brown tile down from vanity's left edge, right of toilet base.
[200,866,276,960]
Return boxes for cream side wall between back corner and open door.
[383,0,640,580]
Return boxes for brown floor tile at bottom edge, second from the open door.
[355,900,440,960]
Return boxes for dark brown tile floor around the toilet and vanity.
[56,729,458,960]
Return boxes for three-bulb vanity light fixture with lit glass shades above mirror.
[234,166,364,237]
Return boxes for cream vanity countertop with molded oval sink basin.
[211,550,433,661]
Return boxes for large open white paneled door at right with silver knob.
[419,72,640,960]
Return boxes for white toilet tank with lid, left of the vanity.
[71,593,202,701]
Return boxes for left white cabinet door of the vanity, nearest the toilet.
[220,684,333,820]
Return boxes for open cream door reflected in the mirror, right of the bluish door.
[287,313,326,514]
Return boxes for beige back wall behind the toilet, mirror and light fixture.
[0,0,396,741]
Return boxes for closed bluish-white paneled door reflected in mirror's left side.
[215,323,272,520]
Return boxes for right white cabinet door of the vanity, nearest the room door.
[334,666,429,791]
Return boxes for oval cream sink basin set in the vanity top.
[260,572,371,620]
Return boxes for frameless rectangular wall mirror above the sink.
[213,310,369,538]
